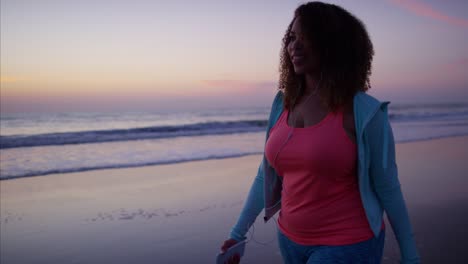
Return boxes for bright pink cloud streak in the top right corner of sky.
[390,0,468,28]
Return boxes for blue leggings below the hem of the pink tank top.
[278,229,385,264]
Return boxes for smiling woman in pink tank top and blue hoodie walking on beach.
[221,2,420,263]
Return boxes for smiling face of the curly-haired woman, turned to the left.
[287,17,318,75]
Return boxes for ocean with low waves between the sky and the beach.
[0,103,468,180]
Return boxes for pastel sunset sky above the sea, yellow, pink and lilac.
[0,0,468,113]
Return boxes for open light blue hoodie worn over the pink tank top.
[230,91,420,264]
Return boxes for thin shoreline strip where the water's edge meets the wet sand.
[0,135,468,182]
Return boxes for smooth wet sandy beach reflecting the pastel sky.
[0,136,468,264]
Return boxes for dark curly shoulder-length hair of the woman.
[278,2,374,111]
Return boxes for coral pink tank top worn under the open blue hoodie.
[265,106,384,245]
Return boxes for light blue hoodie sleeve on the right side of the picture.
[367,104,420,264]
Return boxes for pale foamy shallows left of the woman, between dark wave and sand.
[0,132,265,179]
